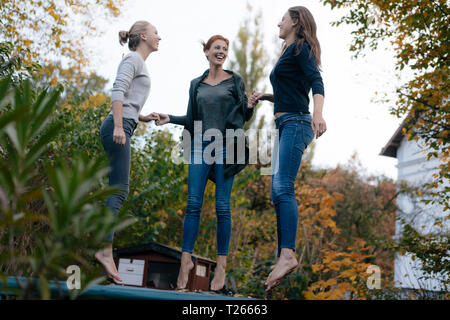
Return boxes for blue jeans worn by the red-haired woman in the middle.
[182,141,234,256]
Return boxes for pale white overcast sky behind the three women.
[87,0,400,179]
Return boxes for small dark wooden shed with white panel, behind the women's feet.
[113,242,216,291]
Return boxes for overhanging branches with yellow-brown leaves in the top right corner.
[322,0,450,210]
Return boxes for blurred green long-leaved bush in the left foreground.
[0,78,133,299]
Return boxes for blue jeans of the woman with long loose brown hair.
[271,112,314,257]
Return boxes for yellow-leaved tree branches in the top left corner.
[0,0,124,78]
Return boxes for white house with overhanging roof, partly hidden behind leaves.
[380,122,450,291]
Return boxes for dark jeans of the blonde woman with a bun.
[100,115,137,242]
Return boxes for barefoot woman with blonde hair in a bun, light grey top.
[94,21,161,283]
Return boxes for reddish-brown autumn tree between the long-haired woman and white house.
[303,155,398,288]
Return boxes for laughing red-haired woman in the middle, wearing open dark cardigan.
[156,35,253,291]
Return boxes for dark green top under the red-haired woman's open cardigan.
[197,77,237,137]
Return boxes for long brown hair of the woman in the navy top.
[288,6,321,70]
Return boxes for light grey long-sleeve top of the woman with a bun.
[110,51,151,123]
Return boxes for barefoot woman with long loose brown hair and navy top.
[249,6,326,291]
